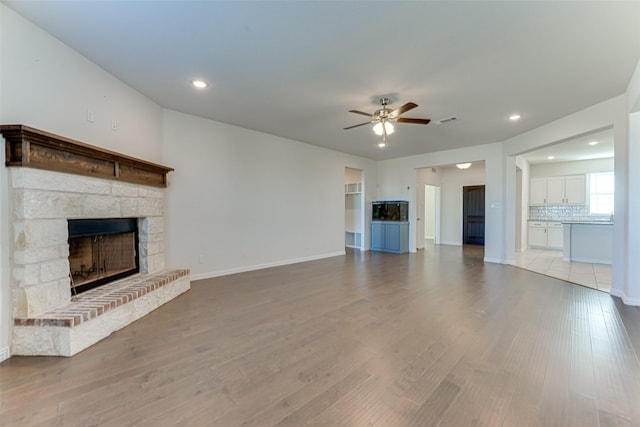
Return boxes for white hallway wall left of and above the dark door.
[440,162,489,246]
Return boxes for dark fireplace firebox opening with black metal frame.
[68,218,140,295]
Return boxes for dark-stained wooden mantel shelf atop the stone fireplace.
[0,125,173,187]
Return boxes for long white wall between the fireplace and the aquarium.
[164,110,376,279]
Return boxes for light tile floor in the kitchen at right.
[515,249,611,292]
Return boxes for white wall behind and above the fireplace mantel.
[0,4,162,359]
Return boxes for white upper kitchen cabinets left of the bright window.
[529,175,587,206]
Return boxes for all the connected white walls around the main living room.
[0,4,640,357]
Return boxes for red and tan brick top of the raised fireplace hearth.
[14,269,189,328]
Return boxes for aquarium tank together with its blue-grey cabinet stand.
[371,201,409,254]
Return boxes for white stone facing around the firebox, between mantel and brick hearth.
[10,167,165,318]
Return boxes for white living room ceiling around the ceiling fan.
[2,0,640,160]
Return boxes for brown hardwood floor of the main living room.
[0,246,640,427]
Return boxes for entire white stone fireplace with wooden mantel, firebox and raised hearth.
[0,125,190,356]
